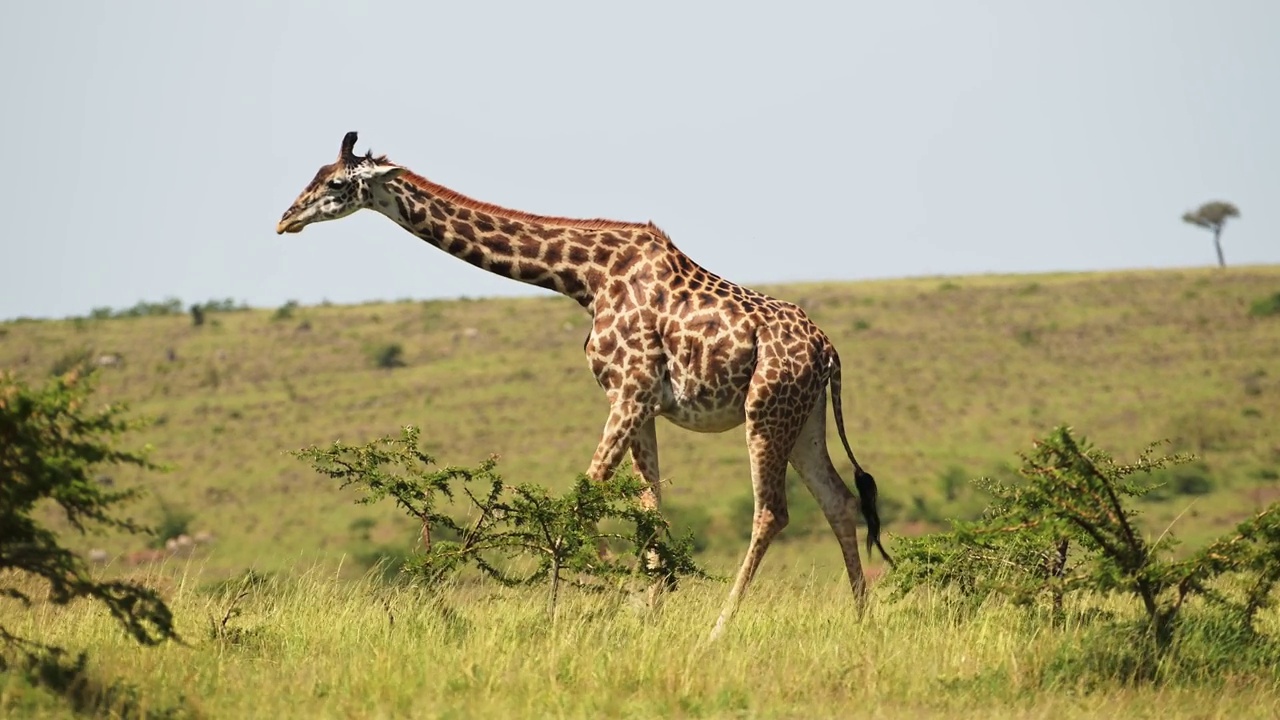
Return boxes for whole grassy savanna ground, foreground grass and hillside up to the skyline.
[0,266,1280,717]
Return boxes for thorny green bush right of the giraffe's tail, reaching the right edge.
[888,428,1280,673]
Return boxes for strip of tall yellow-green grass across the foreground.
[0,566,1280,719]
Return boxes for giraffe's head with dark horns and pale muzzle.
[275,132,404,234]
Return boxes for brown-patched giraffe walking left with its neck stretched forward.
[275,132,892,638]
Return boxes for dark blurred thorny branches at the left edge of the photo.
[0,370,177,670]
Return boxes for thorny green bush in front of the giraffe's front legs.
[293,425,703,614]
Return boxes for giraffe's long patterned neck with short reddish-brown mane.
[374,173,650,309]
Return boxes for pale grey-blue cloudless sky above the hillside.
[0,0,1280,318]
